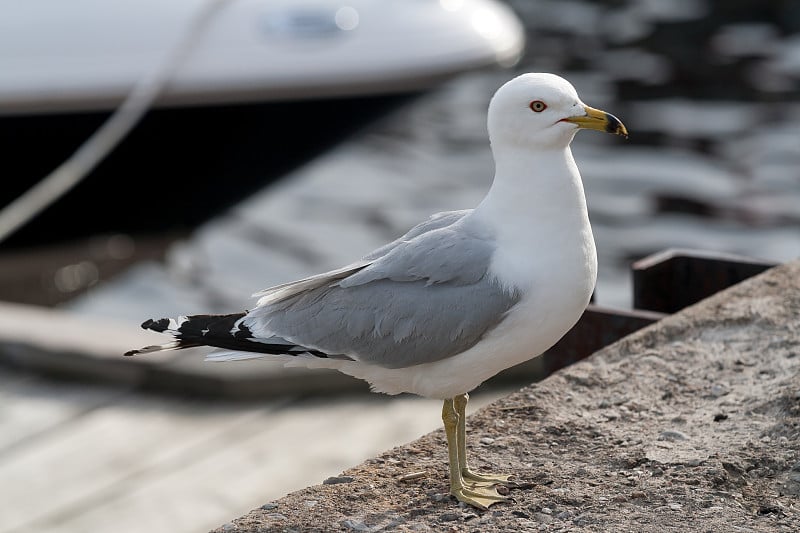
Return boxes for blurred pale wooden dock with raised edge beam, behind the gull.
[0,304,502,533]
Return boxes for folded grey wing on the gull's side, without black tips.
[243,212,519,368]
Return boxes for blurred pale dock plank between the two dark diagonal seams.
[0,386,286,533]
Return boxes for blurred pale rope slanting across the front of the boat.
[0,0,228,242]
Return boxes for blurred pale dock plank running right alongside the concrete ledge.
[36,398,446,533]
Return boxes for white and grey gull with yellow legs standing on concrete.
[125,73,628,509]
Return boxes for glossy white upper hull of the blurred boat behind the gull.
[0,0,524,114]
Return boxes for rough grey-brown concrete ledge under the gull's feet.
[217,262,800,533]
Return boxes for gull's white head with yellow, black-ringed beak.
[488,72,628,149]
